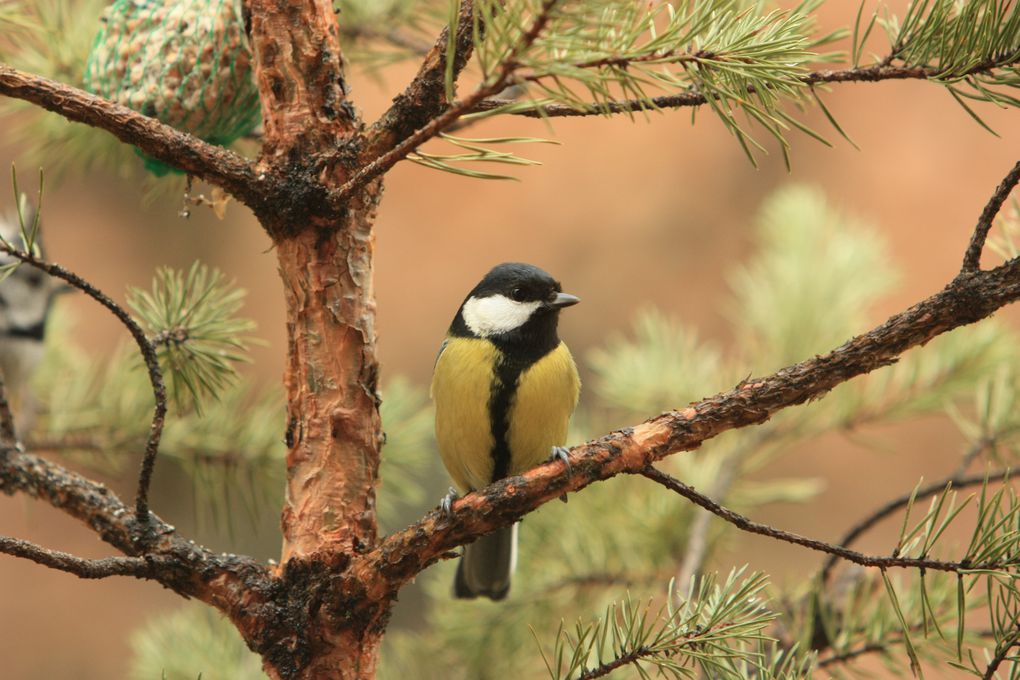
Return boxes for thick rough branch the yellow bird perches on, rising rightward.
[352,160,1020,596]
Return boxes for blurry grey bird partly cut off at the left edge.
[0,197,67,424]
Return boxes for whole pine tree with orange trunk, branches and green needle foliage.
[0,0,1020,678]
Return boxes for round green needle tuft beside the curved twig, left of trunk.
[128,262,255,412]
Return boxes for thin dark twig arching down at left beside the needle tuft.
[0,243,166,522]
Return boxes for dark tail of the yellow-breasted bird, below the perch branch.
[453,524,517,599]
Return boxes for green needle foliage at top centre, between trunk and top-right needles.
[461,0,839,167]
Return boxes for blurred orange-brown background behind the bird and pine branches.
[0,0,1020,680]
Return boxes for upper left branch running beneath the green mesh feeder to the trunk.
[0,64,265,209]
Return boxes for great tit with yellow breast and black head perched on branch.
[431,262,580,599]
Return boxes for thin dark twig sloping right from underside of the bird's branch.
[641,466,1014,574]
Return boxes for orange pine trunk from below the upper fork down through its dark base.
[258,182,390,680]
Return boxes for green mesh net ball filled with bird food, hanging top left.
[85,0,259,174]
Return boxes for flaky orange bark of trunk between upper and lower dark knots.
[276,195,380,561]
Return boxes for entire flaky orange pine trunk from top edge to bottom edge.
[242,0,393,680]
